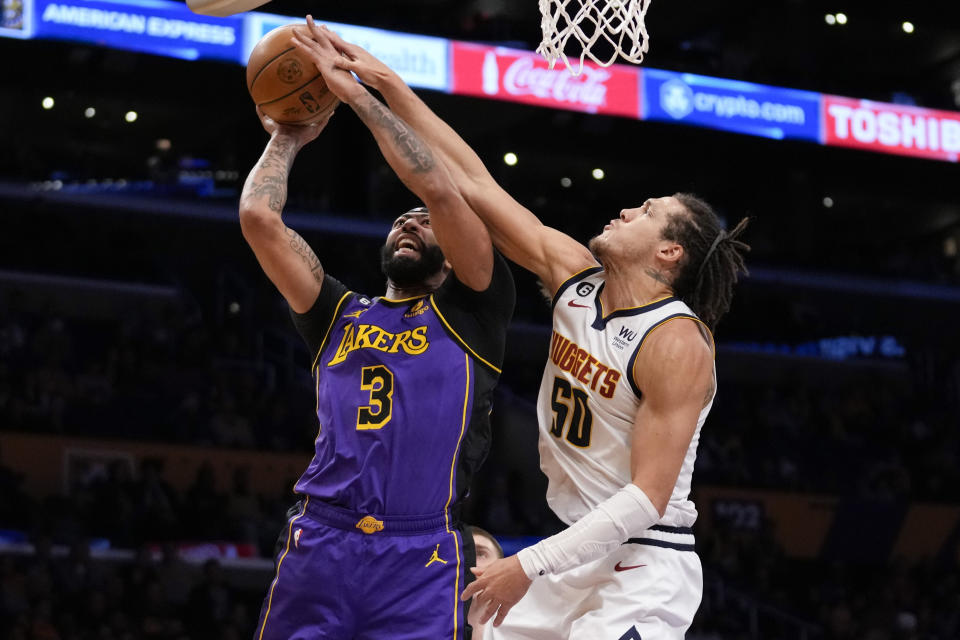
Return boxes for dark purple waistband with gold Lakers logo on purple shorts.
[301,498,460,536]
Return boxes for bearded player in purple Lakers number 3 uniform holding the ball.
[240,61,515,640]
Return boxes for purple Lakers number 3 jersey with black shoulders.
[294,258,513,516]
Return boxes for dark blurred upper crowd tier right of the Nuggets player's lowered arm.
[697,380,960,503]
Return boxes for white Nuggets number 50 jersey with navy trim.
[537,267,715,527]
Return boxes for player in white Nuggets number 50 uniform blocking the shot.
[296,21,748,640]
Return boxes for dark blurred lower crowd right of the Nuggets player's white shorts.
[687,526,960,640]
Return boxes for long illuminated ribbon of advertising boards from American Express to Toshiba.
[7,0,960,162]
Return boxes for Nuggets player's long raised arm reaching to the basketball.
[307,17,597,291]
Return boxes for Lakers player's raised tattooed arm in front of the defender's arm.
[294,22,493,291]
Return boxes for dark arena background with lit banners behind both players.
[0,0,960,640]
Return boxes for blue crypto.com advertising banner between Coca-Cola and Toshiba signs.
[641,68,820,142]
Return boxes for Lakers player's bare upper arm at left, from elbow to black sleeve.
[240,208,323,313]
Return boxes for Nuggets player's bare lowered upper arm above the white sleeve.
[630,318,714,513]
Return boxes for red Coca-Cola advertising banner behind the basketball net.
[450,42,641,118]
